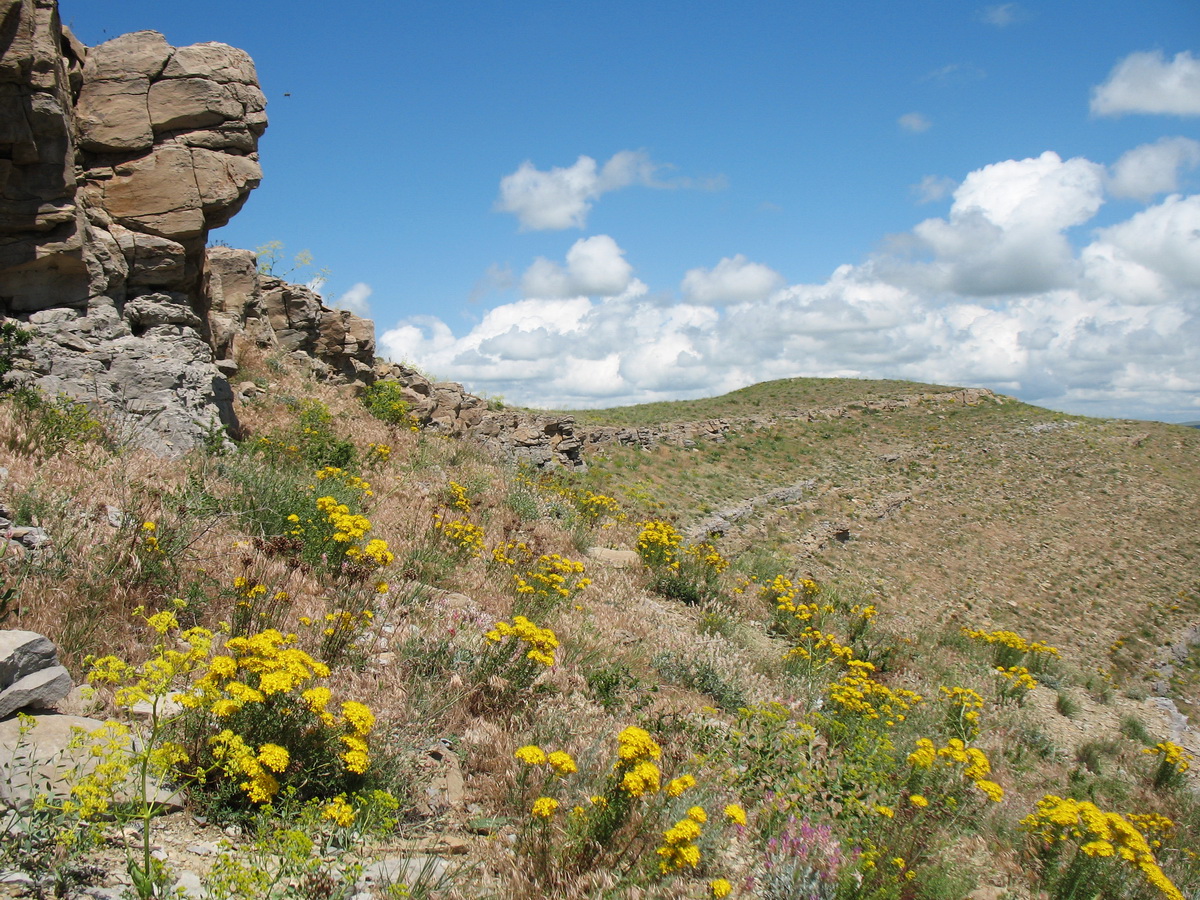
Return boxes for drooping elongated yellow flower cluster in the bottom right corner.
[1021,794,1183,900]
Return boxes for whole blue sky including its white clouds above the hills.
[60,0,1200,421]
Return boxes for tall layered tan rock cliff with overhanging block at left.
[0,0,374,454]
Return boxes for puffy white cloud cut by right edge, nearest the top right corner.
[1092,50,1200,115]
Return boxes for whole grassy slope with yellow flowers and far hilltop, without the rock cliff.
[0,367,1200,900]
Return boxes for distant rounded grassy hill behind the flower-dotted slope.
[566,379,1200,701]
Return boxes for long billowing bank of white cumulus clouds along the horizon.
[380,154,1200,420]
